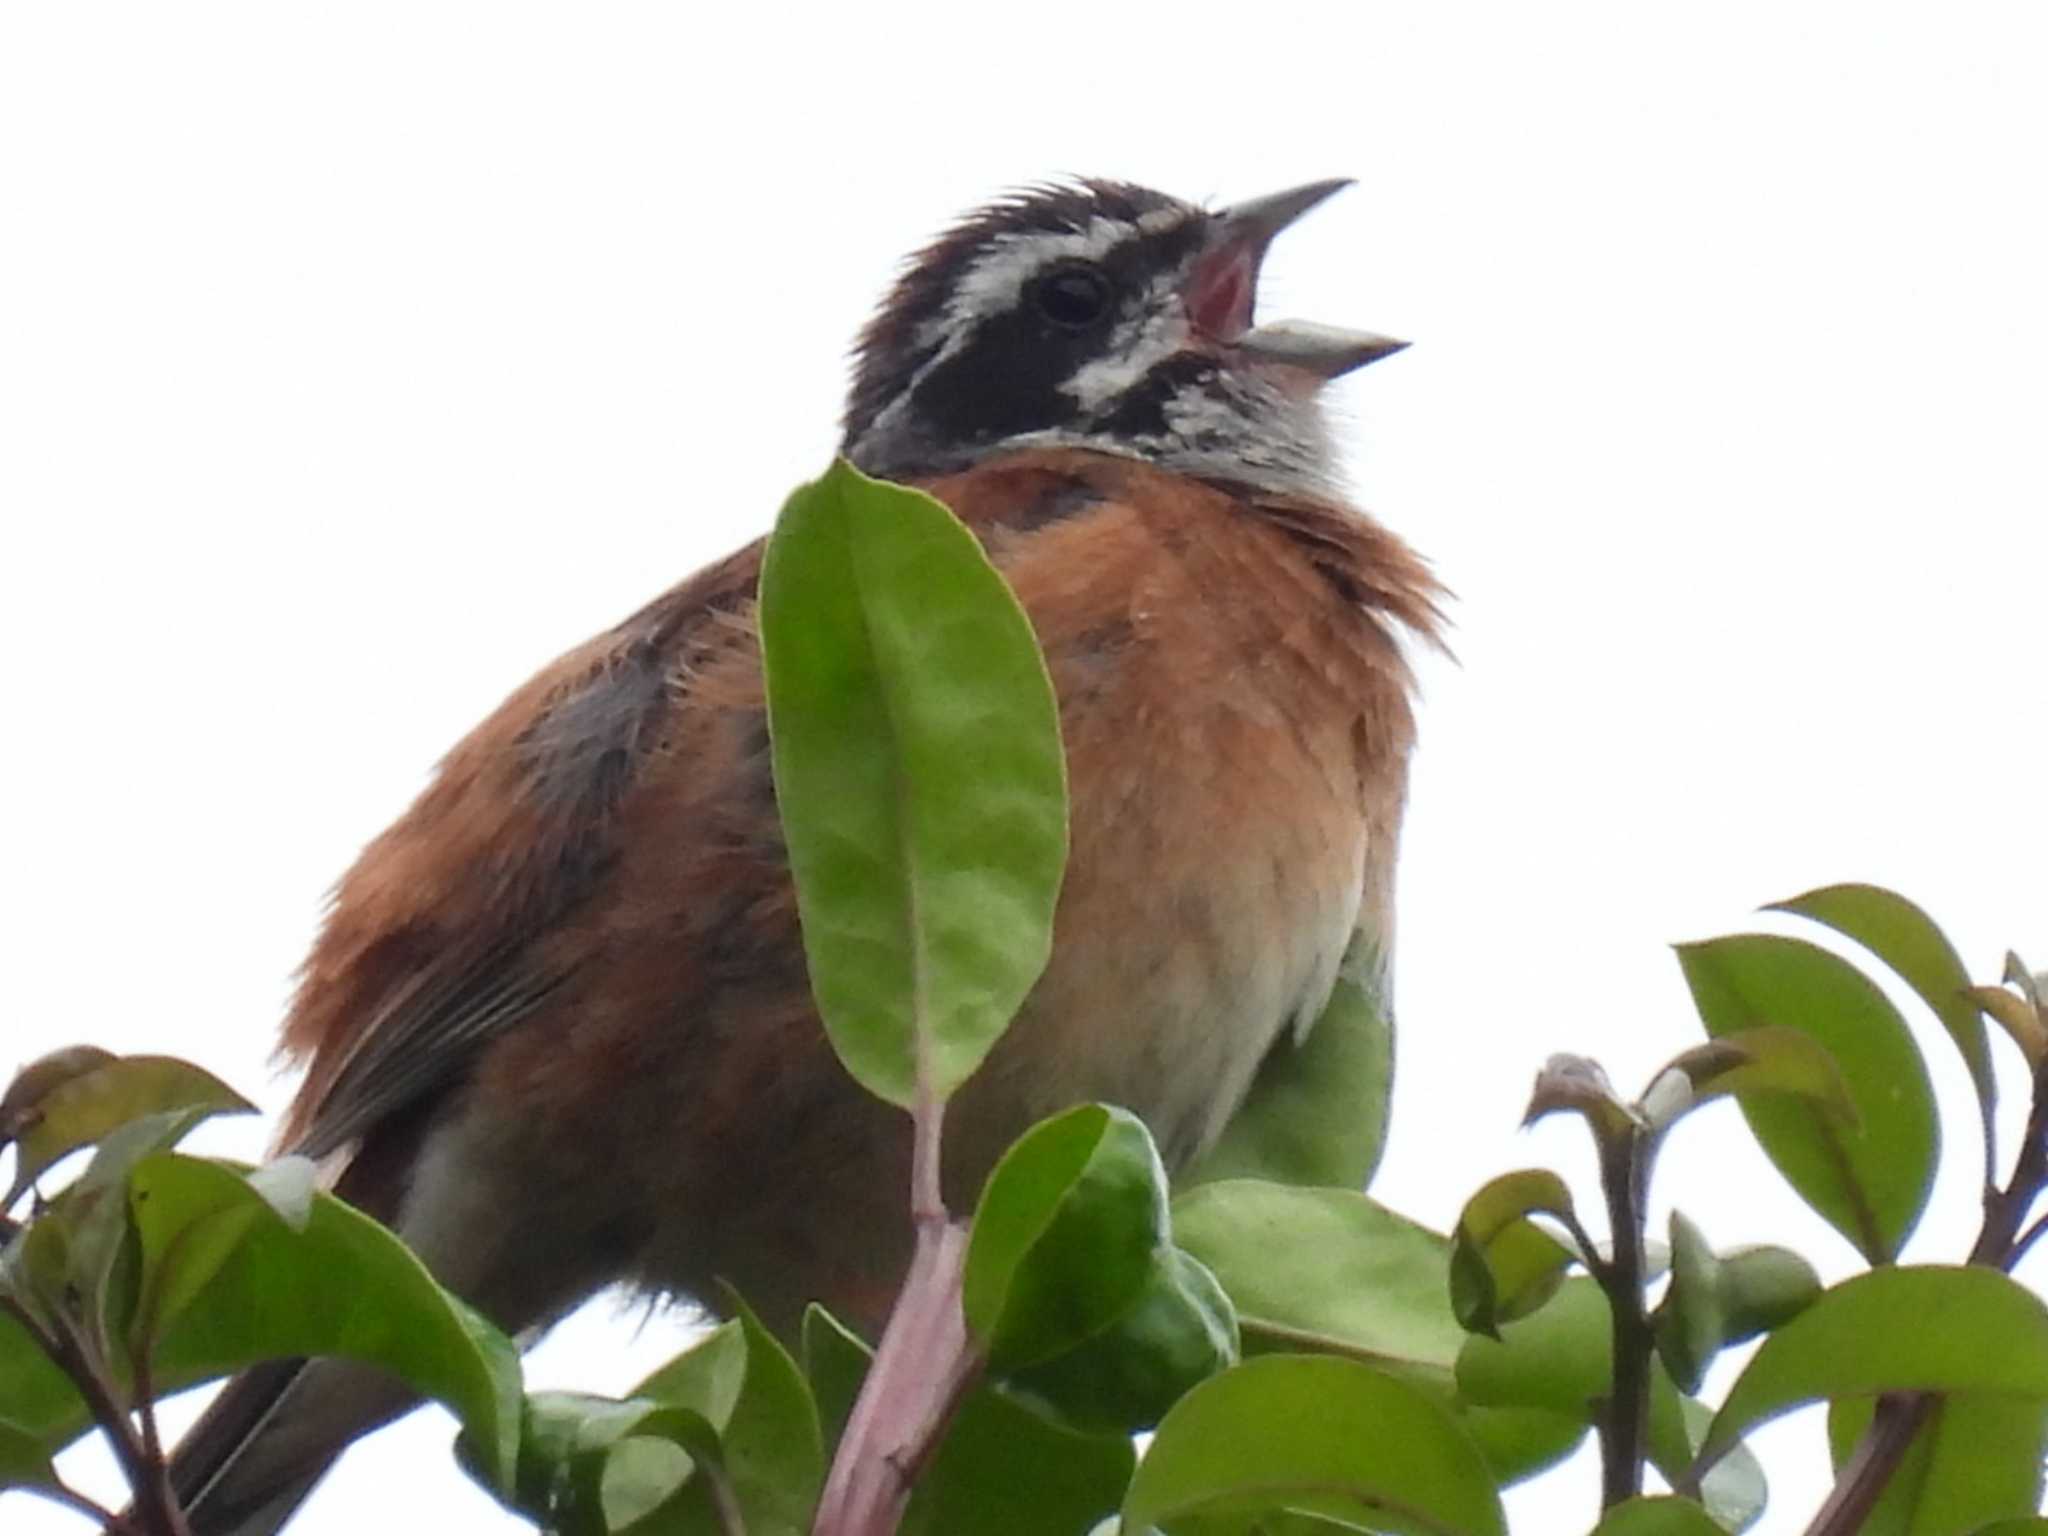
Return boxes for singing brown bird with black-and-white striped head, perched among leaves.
[172,180,1444,1536]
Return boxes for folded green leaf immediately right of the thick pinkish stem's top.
[961,1104,1167,1370]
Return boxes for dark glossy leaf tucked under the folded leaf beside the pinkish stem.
[1006,1247,1237,1434]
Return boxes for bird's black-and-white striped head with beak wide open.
[844,180,1403,489]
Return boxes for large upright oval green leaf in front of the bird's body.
[760,461,1067,1106]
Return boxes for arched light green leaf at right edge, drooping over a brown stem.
[1702,1266,2048,1456]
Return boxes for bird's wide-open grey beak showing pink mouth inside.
[1188,176,1407,379]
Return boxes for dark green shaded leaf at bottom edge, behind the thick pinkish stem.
[803,1307,1137,1536]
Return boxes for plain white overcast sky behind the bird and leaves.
[0,2,2048,1536]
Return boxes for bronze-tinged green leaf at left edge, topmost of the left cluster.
[0,1047,256,1210]
